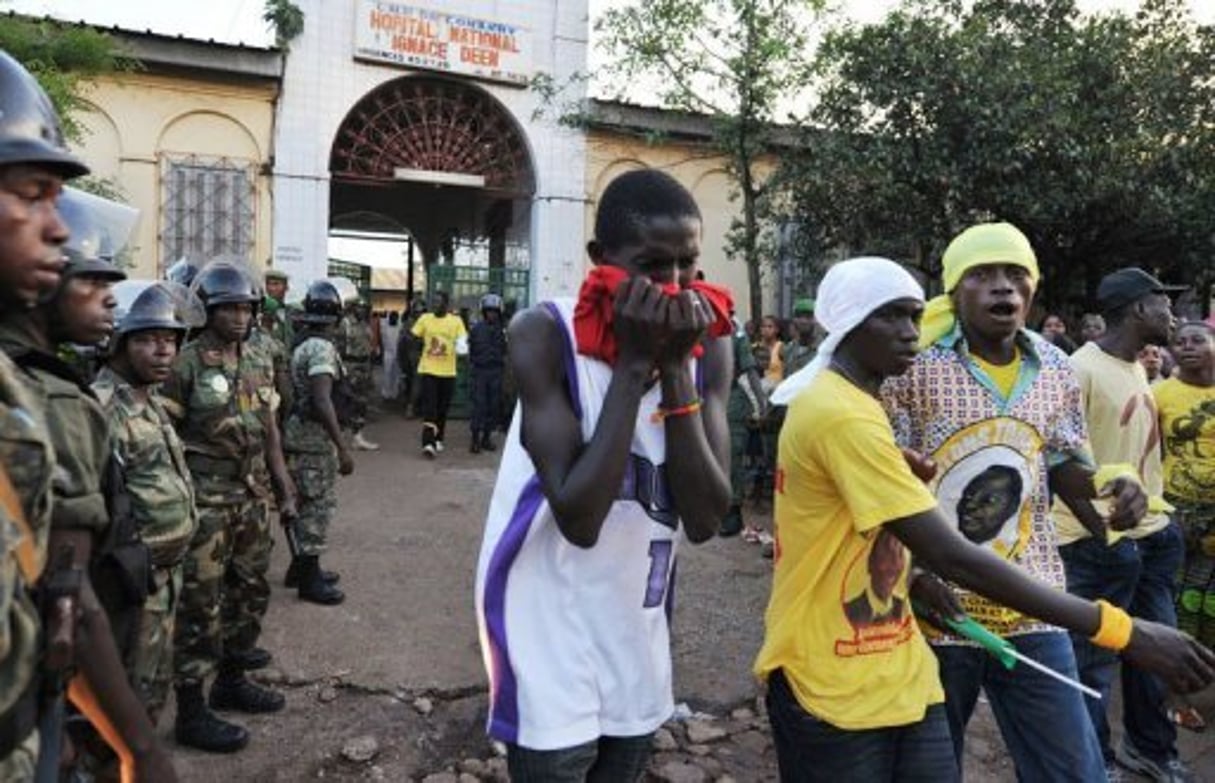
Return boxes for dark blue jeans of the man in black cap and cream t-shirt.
[1059,522,1185,765]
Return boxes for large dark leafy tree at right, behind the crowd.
[781,0,1215,306]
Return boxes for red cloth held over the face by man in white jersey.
[573,265,734,365]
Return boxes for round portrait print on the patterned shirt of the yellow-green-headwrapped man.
[932,418,1041,559]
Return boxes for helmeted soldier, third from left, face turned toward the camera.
[92,282,198,723]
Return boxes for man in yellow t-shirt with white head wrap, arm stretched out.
[755,258,1215,783]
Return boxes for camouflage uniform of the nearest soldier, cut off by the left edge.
[0,354,53,781]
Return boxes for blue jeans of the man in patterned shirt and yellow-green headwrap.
[933,631,1106,783]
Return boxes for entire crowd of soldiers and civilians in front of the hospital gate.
[0,41,1215,783]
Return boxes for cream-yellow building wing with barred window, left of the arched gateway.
[77,30,282,277]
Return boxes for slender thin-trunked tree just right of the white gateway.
[595,0,821,316]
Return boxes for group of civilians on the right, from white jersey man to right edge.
[476,170,1215,783]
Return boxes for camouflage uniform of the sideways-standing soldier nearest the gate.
[283,337,346,554]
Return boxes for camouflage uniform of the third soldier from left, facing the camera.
[92,367,198,723]
